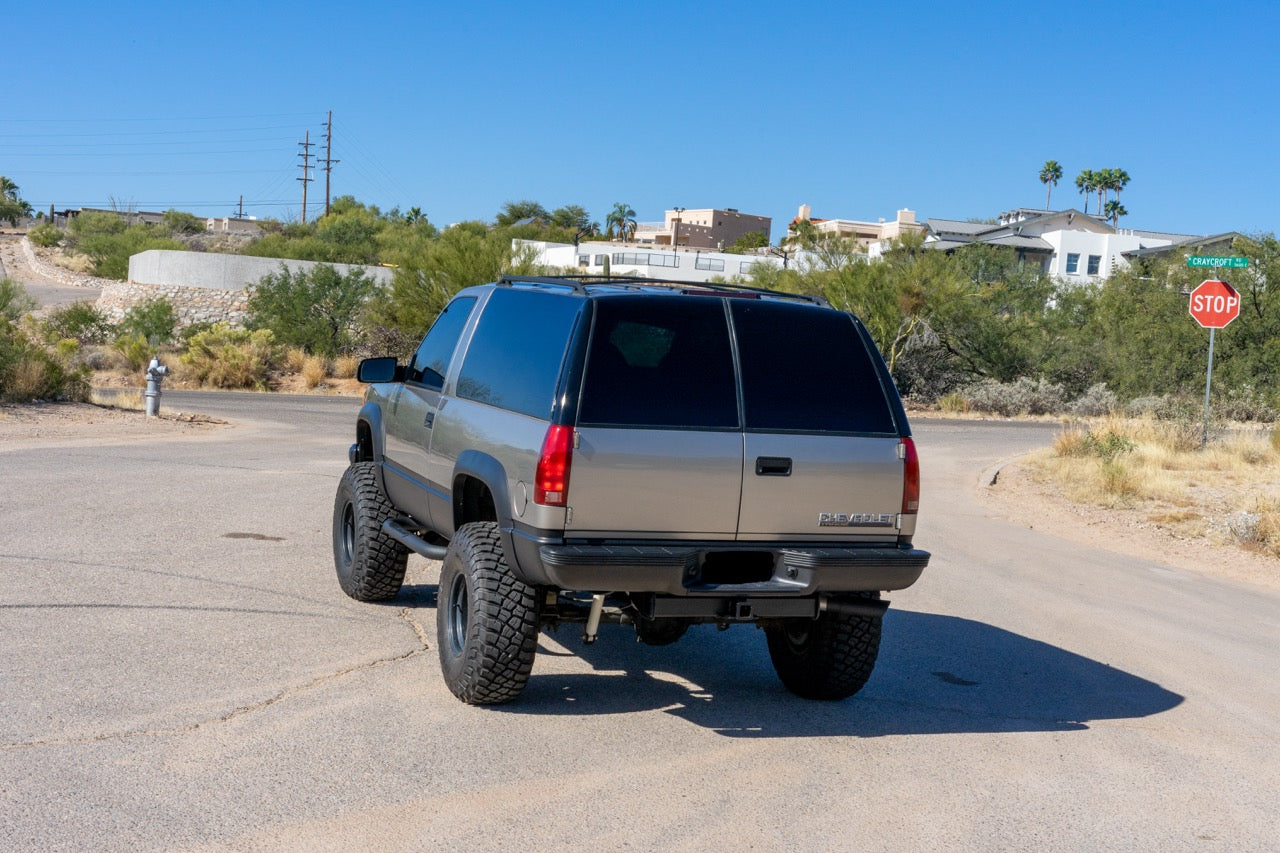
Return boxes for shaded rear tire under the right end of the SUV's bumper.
[764,596,883,699]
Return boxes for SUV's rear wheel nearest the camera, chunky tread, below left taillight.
[435,521,538,704]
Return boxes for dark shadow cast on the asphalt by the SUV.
[495,610,1183,738]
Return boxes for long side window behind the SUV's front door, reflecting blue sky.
[458,287,582,418]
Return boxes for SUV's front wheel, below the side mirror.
[333,462,408,601]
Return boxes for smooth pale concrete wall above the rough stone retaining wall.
[129,248,392,291]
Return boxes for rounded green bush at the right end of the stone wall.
[247,264,378,357]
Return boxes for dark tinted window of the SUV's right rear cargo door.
[731,300,895,433]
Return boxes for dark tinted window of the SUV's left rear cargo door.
[579,297,737,429]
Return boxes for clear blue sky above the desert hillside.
[0,0,1280,238]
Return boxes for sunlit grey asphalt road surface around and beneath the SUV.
[0,392,1280,850]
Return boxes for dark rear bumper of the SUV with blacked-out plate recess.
[512,533,929,597]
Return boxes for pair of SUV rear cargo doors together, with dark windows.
[566,295,905,542]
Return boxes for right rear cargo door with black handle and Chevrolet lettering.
[730,300,904,542]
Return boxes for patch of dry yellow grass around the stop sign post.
[1028,416,1280,556]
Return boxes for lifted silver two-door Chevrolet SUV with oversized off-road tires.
[333,277,929,704]
